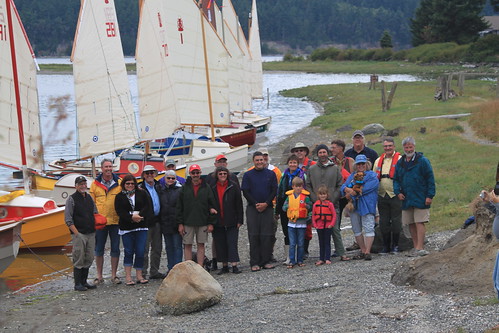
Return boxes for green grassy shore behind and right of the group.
[282,80,499,232]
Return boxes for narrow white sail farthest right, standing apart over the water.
[248,0,263,98]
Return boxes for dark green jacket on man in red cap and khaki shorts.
[176,178,216,227]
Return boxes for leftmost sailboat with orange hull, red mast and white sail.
[0,0,71,247]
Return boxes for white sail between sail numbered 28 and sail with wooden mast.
[135,0,180,140]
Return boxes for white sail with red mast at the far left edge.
[0,0,43,169]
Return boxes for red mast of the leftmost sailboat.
[6,0,30,194]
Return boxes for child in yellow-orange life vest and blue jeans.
[282,177,312,268]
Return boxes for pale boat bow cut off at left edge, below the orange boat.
[0,221,22,273]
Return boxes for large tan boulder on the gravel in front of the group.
[156,260,222,315]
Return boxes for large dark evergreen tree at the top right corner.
[411,0,487,46]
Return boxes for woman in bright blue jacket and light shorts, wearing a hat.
[341,154,379,260]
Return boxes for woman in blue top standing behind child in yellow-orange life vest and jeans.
[275,155,305,265]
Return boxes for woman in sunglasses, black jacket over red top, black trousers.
[212,167,243,275]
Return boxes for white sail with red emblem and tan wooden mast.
[165,0,230,125]
